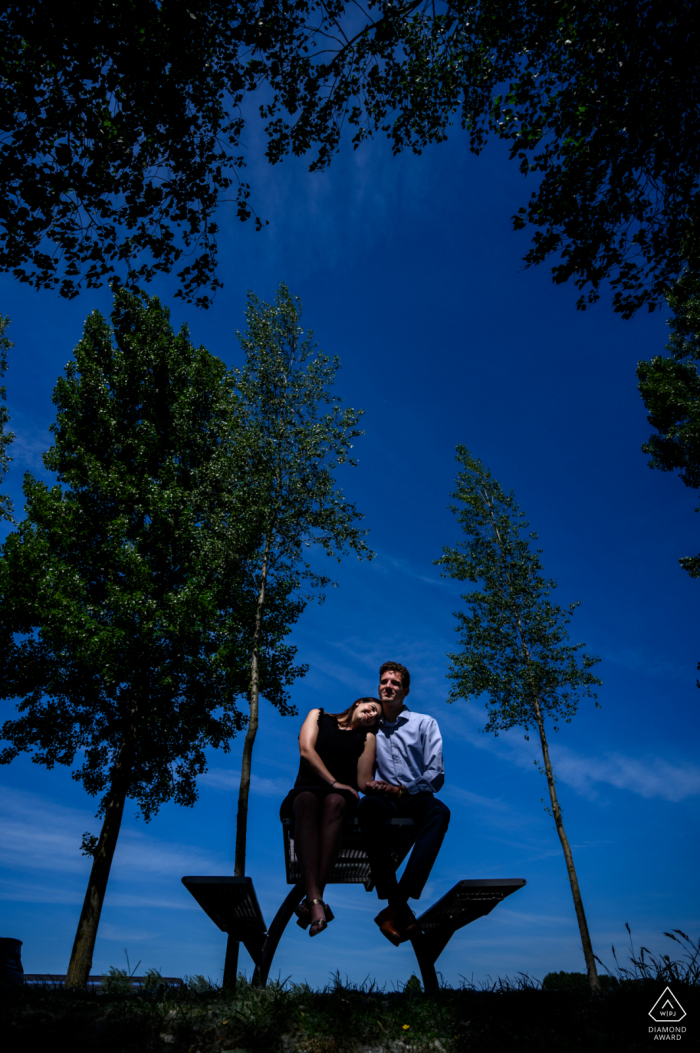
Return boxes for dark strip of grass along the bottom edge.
[0,930,700,1053]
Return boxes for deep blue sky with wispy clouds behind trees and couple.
[0,123,700,987]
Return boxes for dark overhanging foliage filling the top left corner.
[0,0,266,305]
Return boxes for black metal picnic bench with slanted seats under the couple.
[182,819,526,992]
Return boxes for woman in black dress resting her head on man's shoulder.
[280,698,381,936]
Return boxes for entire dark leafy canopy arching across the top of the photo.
[0,0,700,316]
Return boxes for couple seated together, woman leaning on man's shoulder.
[280,661,449,947]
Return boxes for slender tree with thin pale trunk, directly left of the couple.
[229,284,372,876]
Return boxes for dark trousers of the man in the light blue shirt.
[358,792,449,906]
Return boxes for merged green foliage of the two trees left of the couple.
[0,286,371,818]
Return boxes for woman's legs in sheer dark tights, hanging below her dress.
[294,793,345,921]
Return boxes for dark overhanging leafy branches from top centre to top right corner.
[255,0,700,317]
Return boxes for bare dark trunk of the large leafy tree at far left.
[65,746,131,988]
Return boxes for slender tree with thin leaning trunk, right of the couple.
[437,446,601,992]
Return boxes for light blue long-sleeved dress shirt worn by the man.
[375,706,445,794]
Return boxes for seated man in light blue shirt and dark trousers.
[358,661,449,947]
